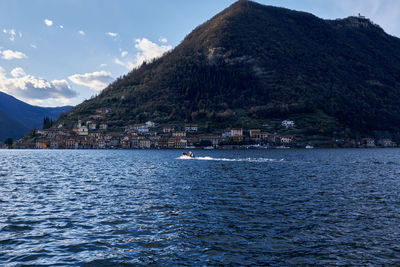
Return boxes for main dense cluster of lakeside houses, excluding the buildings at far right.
[11,118,295,149]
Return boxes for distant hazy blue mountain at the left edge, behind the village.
[0,92,72,141]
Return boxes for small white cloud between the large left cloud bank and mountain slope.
[68,70,113,91]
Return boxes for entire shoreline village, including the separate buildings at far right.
[3,108,397,149]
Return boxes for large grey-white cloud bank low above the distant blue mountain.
[0,67,77,103]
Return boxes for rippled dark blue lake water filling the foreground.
[0,149,400,266]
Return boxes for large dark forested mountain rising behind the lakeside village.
[61,0,400,136]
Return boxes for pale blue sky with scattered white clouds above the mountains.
[0,0,400,107]
